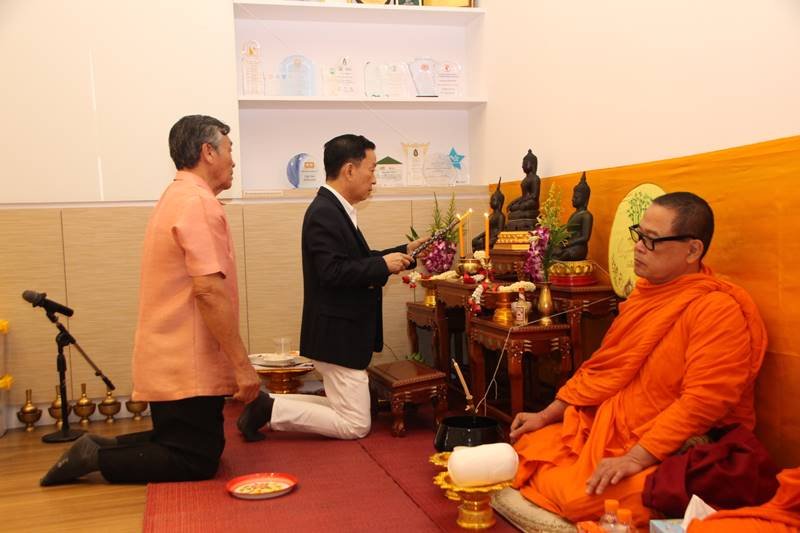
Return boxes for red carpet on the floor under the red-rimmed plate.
[143,404,516,533]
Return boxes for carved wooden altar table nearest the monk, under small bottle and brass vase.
[469,316,577,422]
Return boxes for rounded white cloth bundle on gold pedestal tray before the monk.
[447,442,519,487]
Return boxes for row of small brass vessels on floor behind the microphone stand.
[17,383,147,431]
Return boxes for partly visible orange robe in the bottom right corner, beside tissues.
[688,468,800,533]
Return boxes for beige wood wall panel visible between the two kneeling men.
[243,203,307,353]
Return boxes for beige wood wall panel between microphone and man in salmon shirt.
[62,207,152,400]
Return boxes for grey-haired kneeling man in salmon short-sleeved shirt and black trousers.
[41,115,260,486]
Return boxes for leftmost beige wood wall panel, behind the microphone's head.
[0,209,66,409]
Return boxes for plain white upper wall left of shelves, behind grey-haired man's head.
[0,0,239,204]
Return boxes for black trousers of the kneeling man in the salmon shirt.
[99,396,225,483]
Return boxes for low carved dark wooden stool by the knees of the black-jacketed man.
[367,361,447,437]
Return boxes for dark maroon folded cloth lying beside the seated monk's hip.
[642,425,778,517]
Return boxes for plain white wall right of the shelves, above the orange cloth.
[471,0,800,181]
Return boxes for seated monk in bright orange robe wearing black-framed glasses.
[511,193,767,524]
